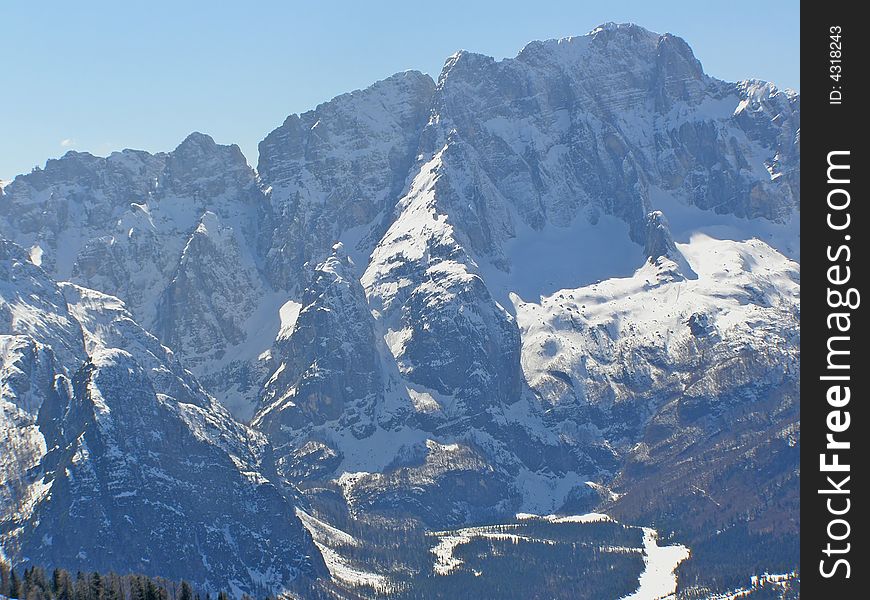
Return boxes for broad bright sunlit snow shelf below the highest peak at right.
[512,233,800,406]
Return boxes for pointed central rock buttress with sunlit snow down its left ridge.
[362,148,520,415]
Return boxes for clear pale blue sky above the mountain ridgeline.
[0,0,800,180]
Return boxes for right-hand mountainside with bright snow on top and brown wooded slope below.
[517,235,800,590]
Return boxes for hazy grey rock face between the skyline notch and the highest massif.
[258,71,435,289]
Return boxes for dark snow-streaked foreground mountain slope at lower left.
[0,241,322,594]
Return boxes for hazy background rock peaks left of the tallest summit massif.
[0,71,434,420]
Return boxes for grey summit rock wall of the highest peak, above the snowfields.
[423,24,800,253]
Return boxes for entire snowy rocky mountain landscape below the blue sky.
[0,23,800,600]
